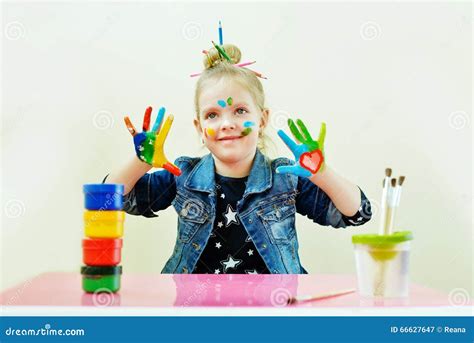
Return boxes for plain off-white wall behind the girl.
[1,1,473,296]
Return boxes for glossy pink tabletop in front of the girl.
[0,272,460,308]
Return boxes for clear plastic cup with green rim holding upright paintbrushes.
[352,168,413,298]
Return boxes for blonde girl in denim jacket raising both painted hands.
[103,44,371,274]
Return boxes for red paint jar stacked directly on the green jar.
[82,238,122,266]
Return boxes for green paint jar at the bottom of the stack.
[81,266,122,293]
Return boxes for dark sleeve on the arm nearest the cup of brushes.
[296,177,372,228]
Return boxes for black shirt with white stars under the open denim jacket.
[193,174,270,274]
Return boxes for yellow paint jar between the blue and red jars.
[84,211,125,238]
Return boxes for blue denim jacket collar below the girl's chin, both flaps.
[184,149,272,197]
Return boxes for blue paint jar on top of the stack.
[83,183,124,211]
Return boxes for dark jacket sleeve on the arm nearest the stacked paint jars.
[102,169,176,218]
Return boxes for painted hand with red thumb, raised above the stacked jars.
[124,107,181,176]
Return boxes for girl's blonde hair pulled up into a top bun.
[194,44,276,157]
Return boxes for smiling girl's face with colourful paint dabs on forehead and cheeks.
[194,79,267,167]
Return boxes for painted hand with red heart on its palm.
[276,119,326,177]
